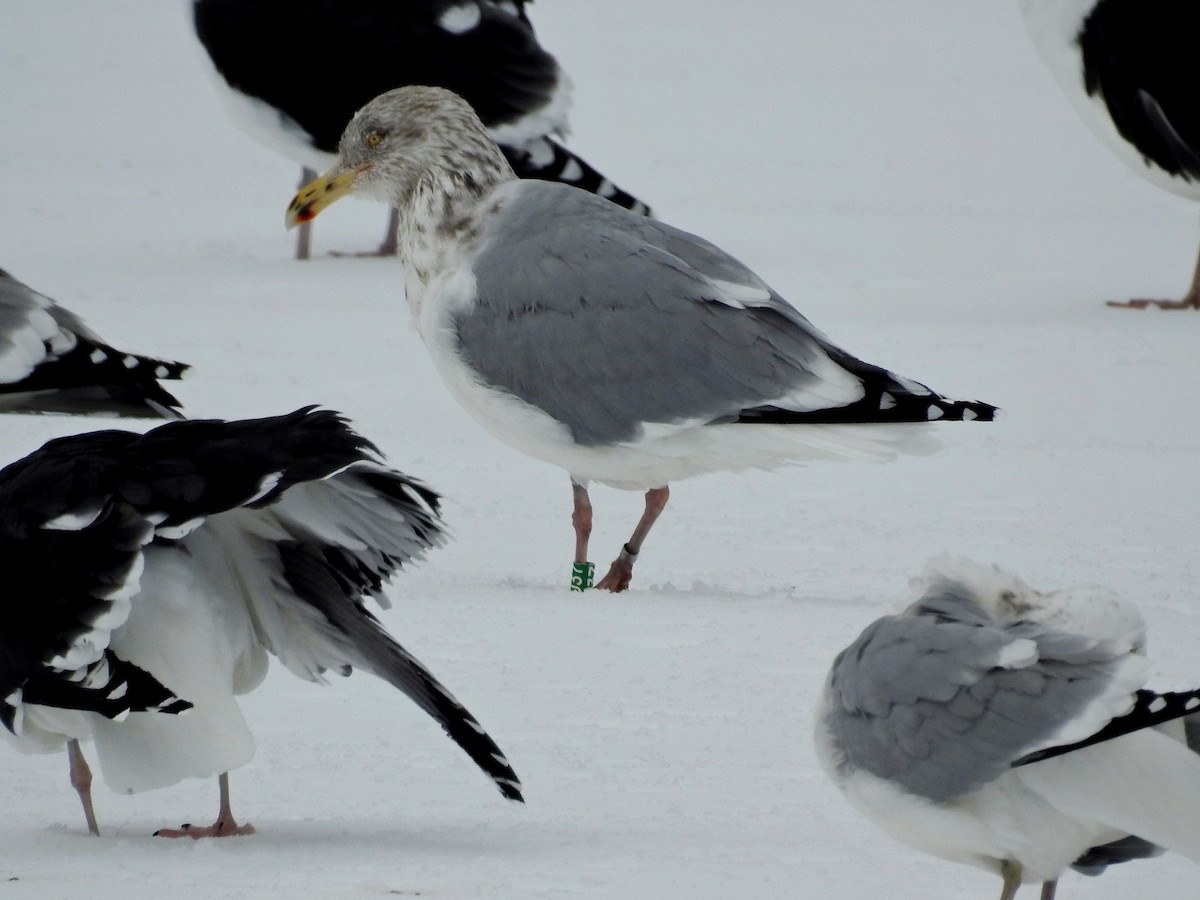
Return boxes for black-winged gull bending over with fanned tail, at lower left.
[0,408,521,836]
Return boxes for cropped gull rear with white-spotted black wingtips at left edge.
[0,269,187,419]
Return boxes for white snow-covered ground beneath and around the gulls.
[0,0,1200,900]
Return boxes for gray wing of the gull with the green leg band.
[456,181,929,445]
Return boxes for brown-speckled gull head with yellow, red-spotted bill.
[284,85,512,228]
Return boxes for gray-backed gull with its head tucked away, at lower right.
[816,560,1200,900]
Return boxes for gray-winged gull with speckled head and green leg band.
[287,86,995,590]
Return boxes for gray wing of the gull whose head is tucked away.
[824,592,1132,802]
